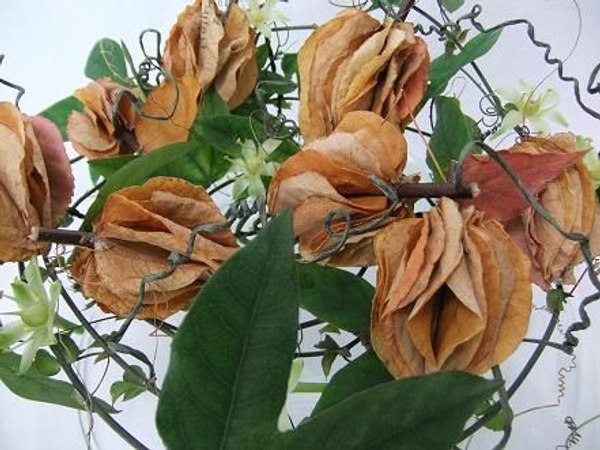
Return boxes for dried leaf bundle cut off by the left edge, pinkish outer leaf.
[0,102,73,261]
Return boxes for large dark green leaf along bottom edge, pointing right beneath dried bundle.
[282,372,500,450]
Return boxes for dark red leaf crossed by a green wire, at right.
[460,150,582,221]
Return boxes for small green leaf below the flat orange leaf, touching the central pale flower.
[192,114,266,157]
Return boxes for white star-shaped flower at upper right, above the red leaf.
[494,80,568,137]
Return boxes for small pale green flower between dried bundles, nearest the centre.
[231,139,281,199]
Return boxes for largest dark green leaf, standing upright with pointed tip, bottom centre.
[157,212,298,450]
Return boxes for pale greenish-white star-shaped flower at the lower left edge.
[0,258,62,374]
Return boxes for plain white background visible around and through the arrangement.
[0,0,600,450]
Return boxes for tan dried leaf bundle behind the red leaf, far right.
[505,133,600,289]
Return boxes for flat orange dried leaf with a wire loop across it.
[135,76,200,153]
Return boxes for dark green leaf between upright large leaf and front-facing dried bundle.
[298,263,375,333]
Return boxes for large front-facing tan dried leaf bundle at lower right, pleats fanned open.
[371,198,531,377]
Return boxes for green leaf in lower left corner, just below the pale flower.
[0,353,117,413]
